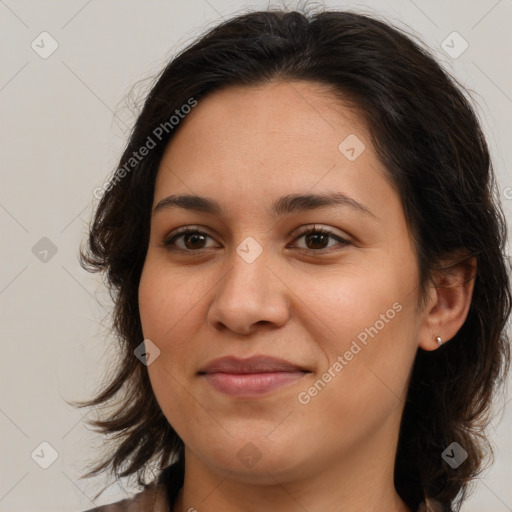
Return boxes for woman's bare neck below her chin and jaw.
[174,414,410,512]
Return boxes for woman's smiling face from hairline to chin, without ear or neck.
[139,82,422,481]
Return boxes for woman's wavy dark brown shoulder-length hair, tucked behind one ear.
[77,6,511,510]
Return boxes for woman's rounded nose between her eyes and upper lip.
[208,248,290,335]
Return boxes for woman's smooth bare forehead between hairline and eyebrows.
[155,82,398,221]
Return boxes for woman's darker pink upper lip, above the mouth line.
[199,356,308,373]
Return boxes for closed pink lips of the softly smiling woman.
[198,356,310,398]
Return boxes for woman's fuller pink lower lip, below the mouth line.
[204,371,305,398]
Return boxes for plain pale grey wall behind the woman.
[0,0,512,512]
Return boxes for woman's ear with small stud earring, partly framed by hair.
[418,257,476,351]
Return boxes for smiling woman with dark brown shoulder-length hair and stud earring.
[77,5,511,512]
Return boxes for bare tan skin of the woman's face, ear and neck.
[139,82,472,512]
